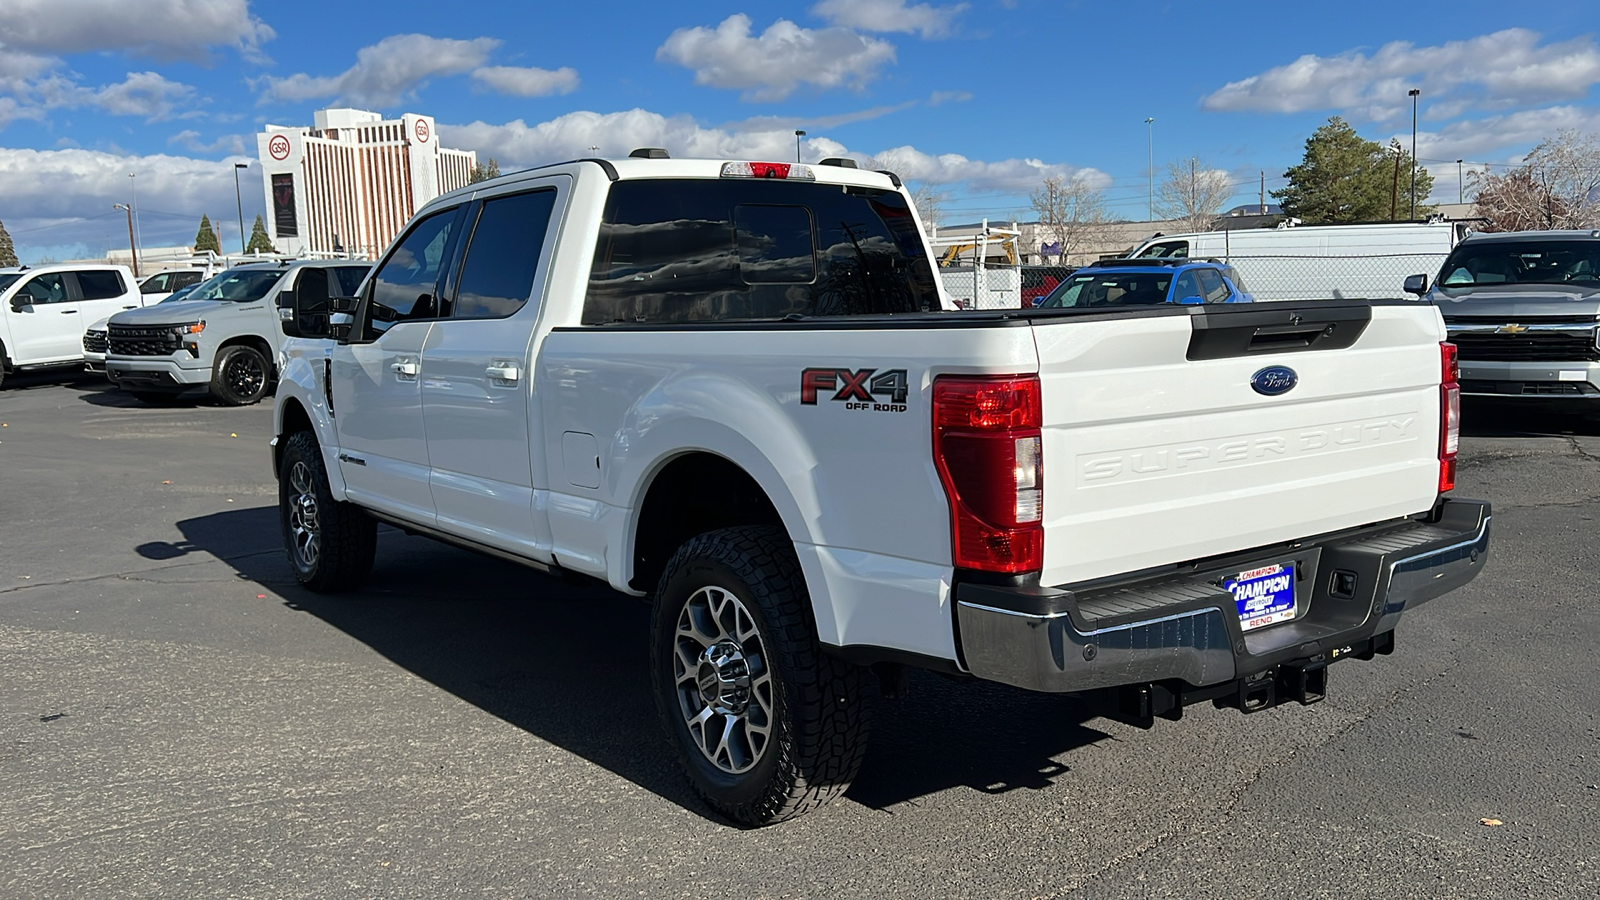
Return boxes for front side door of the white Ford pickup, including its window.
[331,207,462,525]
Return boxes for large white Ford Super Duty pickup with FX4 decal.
[274,151,1490,825]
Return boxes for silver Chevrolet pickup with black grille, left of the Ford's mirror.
[106,259,371,407]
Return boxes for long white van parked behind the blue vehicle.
[1128,223,1466,301]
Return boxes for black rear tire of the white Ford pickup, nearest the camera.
[650,527,870,826]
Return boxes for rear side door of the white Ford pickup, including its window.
[421,176,571,559]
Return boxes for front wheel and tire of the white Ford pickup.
[278,431,378,594]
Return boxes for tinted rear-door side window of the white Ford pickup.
[453,191,555,319]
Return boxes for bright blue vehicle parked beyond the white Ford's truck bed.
[1038,259,1253,309]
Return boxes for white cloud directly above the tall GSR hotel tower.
[262,34,501,107]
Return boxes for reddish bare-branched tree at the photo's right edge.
[1472,130,1600,231]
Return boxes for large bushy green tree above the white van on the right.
[1272,115,1434,224]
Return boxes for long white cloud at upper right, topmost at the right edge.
[1202,29,1600,122]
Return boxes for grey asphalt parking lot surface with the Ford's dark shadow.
[0,368,1600,898]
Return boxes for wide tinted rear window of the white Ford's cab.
[582,179,939,325]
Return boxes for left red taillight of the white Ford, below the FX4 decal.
[933,375,1045,573]
